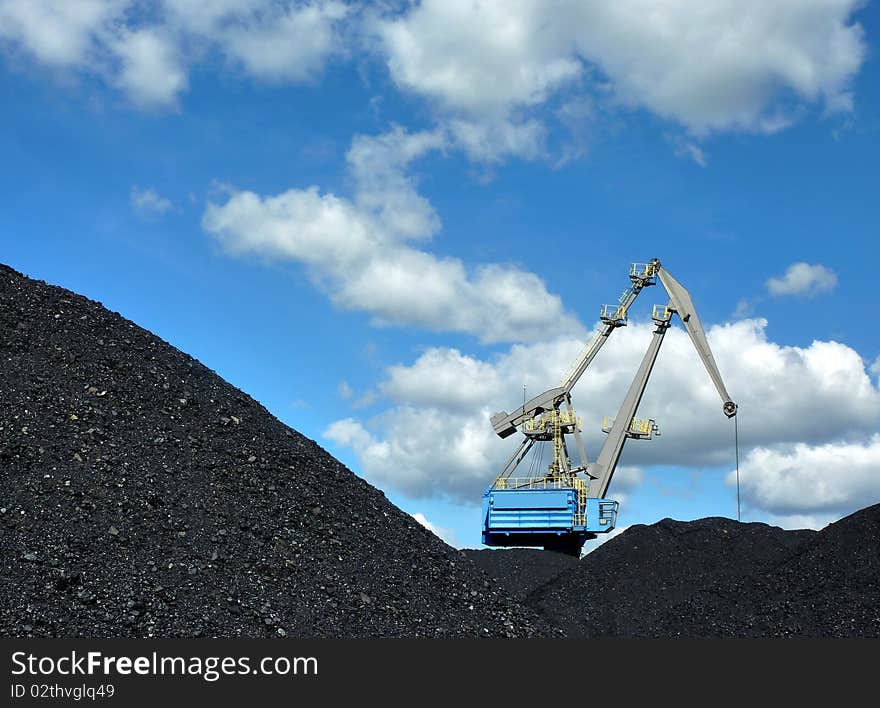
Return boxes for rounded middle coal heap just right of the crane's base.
[527,518,815,638]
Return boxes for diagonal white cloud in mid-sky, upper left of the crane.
[202,128,581,342]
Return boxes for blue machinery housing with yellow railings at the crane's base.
[483,478,618,556]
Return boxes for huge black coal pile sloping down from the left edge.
[0,266,551,637]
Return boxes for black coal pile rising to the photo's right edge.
[657,504,880,638]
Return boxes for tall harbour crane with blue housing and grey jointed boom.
[483,258,737,556]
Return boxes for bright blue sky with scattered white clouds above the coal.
[0,0,880,545]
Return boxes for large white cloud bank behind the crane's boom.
[324,319,880,503]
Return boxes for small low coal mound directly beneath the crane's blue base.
[463,548,578,600]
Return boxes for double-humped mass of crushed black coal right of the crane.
[526,505,880,638]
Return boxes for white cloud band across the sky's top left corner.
[0,0,350,109]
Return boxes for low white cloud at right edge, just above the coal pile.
[727,433,880,518]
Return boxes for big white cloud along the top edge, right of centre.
[379,0,866,134]
